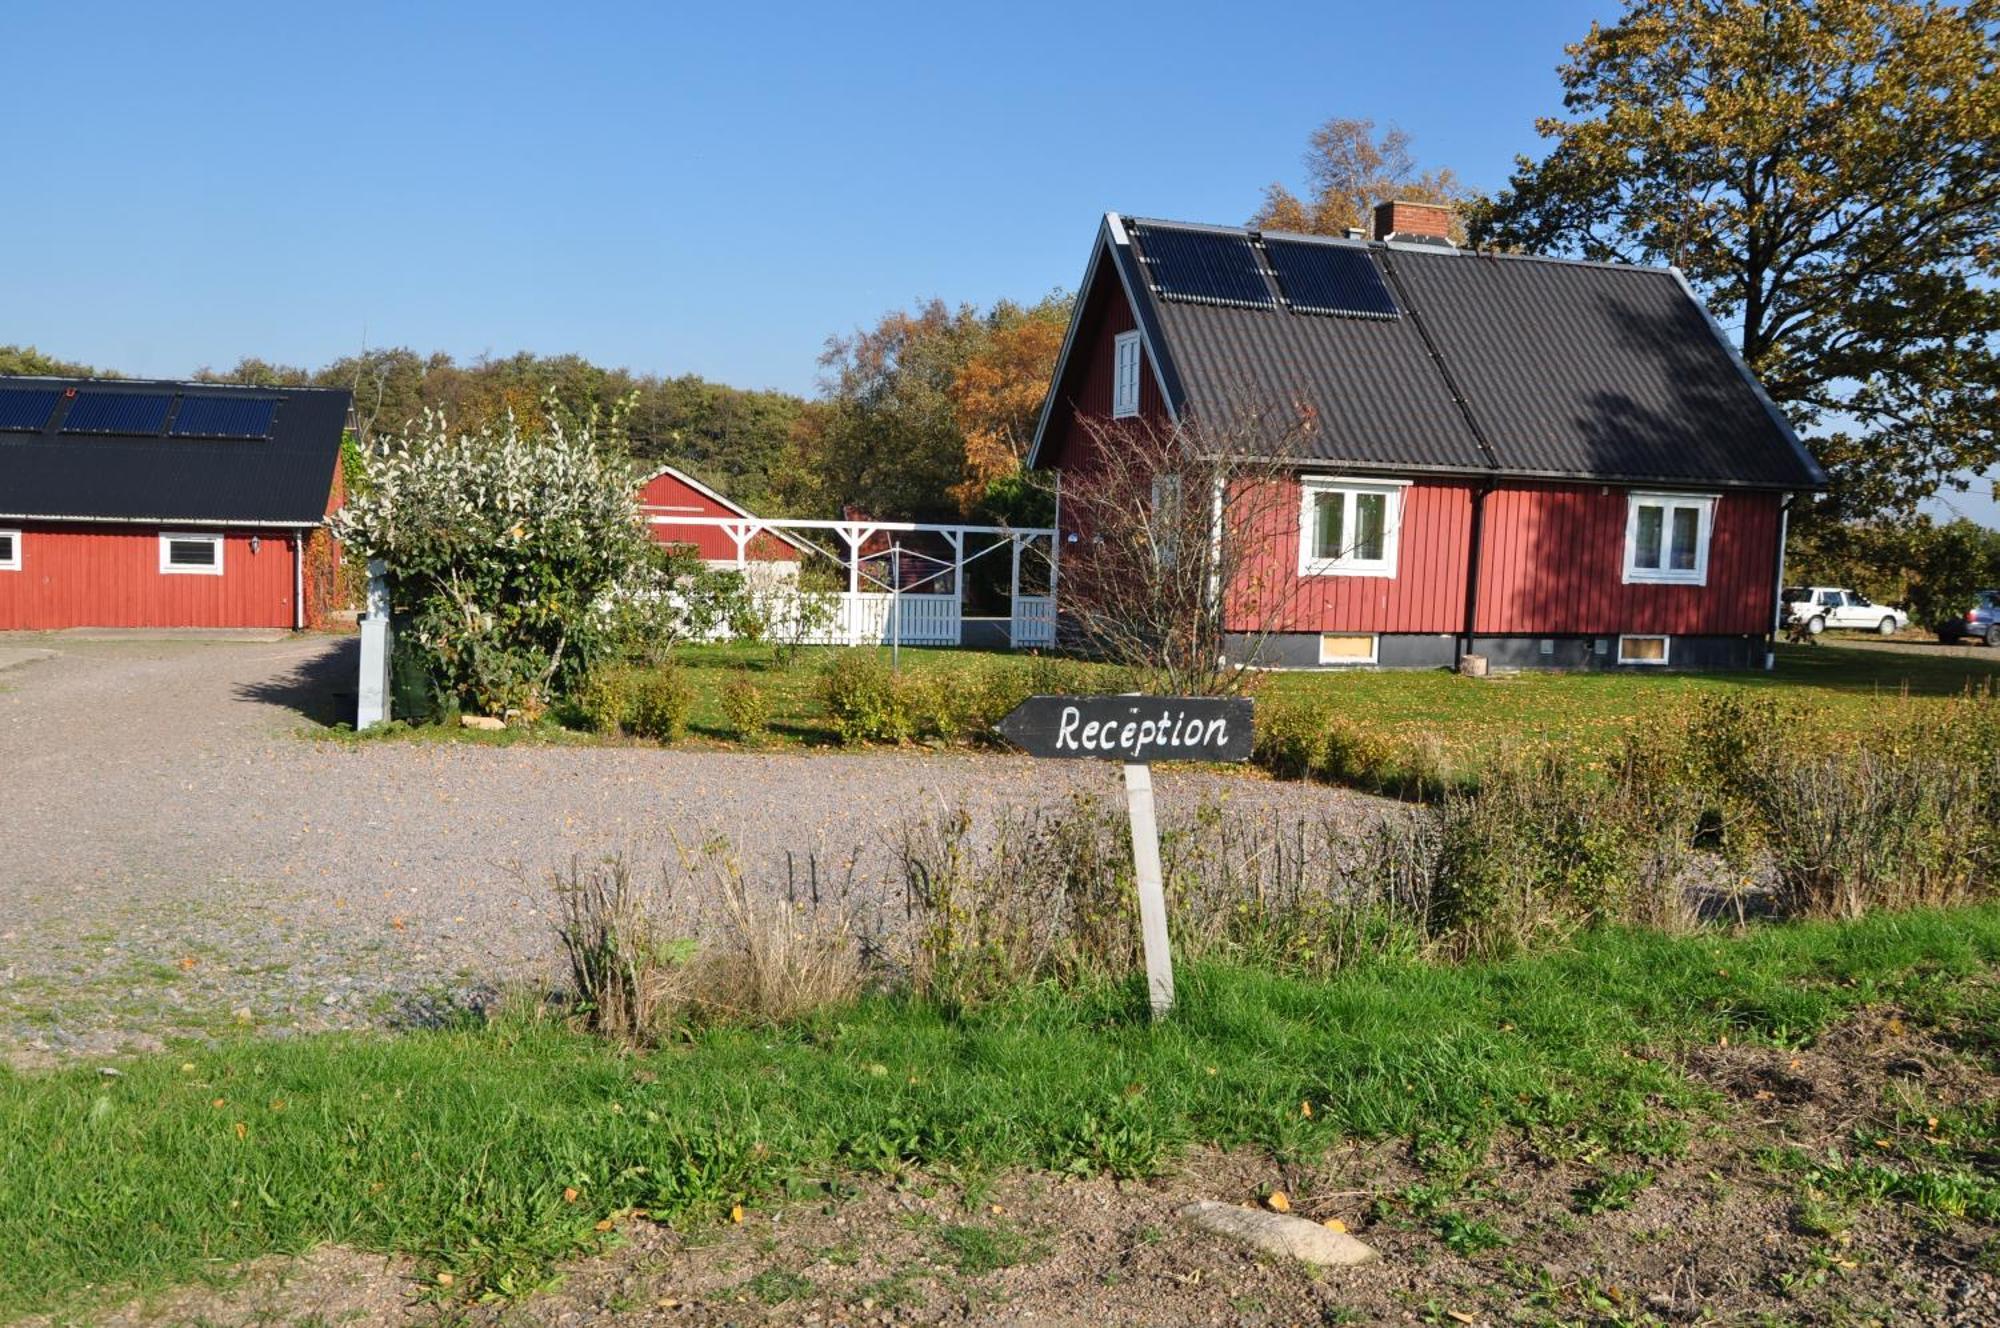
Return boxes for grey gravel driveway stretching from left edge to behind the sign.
[0,634,1376,1064]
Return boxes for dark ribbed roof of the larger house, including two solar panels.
[1036,214,1826,490]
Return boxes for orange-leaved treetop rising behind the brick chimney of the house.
[1250,116,1468,236]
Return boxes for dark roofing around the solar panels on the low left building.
[0,378,348,526]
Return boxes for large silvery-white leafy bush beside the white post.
[334,410,728,714]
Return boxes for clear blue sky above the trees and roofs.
[0,0,1614,392]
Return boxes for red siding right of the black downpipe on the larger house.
[1478,484,1780,636]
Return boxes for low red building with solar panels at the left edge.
[0,378,348,630]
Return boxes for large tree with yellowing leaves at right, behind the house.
[1470,0,2000,516]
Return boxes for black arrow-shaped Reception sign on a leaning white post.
[1000,696,1252,1018]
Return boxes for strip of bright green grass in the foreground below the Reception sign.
[0,906,2000,1318]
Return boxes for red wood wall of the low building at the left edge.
[0,522,292,632]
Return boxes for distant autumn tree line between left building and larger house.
[0,292,1070,518]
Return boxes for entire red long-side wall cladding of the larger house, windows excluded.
[1230,480,1780,636]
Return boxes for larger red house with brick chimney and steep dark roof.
[1030,202,1826,668]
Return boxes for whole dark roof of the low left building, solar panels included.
[0,376,348,526]
